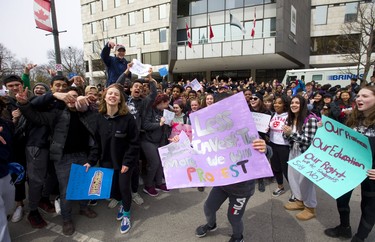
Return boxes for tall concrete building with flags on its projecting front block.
[81,0,371,83]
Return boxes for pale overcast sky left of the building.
[0,0,83,64]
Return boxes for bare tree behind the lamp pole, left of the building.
[47,47,85,76]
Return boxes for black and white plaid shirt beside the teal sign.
[286,117,318,153]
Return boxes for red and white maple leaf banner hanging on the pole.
[34,0,52,32]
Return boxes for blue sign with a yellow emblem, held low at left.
[66,164,113,200]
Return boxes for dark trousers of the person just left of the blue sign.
[55,152,87,222]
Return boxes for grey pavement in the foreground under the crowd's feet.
[9,183,375,242]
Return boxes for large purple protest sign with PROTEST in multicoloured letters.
[159,93,273,188]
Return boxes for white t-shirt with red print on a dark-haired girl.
[269,112,289,145]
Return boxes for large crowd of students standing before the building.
[0,57,375,241]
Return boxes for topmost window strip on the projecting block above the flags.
[177,0,276,17]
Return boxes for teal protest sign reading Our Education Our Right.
[288,116,372,199]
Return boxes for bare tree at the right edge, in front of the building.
[338,2,375,85]
